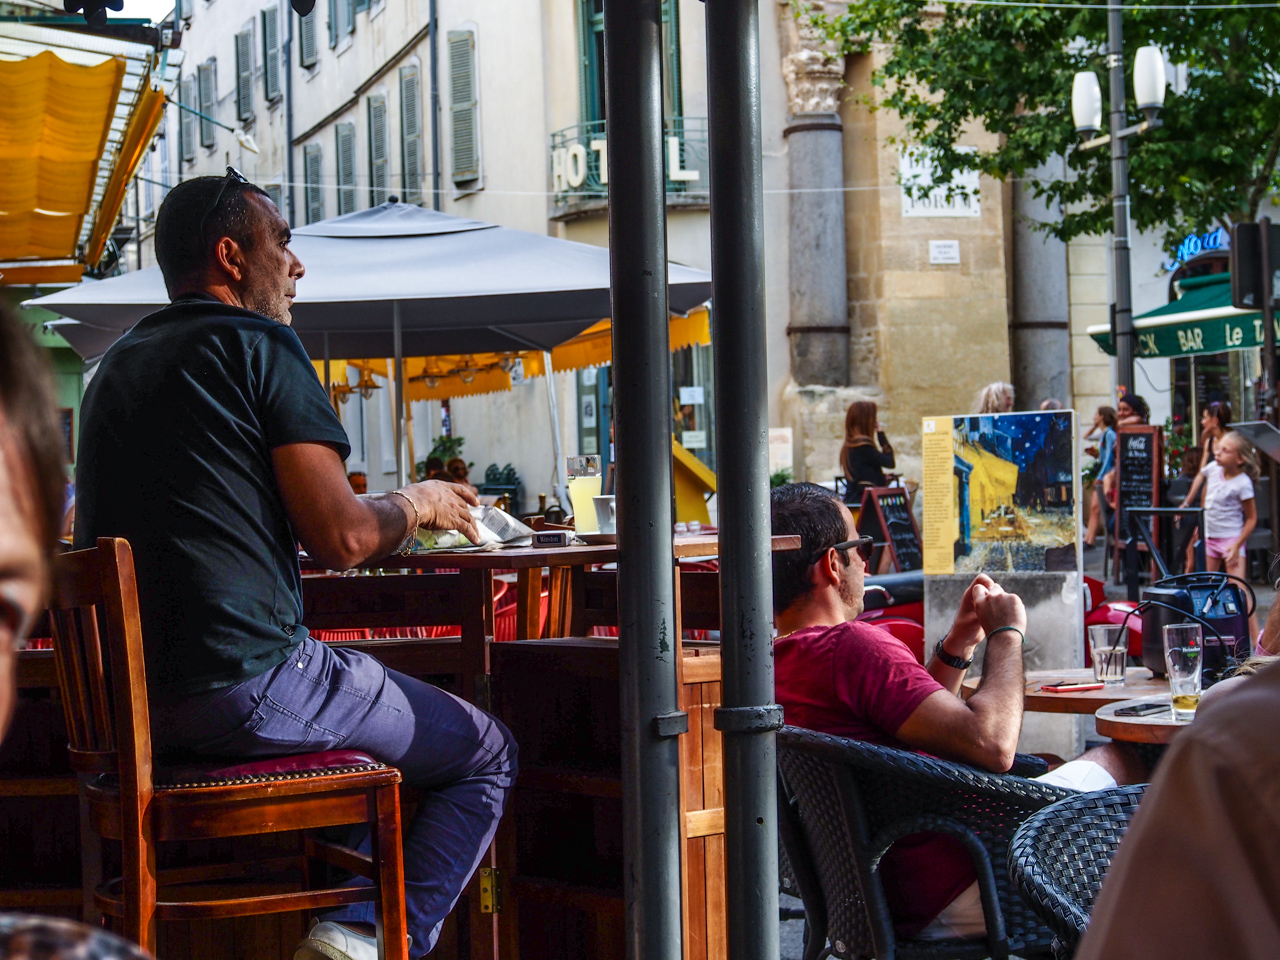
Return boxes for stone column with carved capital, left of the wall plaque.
[781,0,849,387]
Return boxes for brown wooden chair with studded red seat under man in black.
[50,539,408,960]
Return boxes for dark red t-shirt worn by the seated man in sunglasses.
[773,621,977,937]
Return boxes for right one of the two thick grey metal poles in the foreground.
[701,0,782,960]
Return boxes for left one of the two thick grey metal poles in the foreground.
[604,0,689,960]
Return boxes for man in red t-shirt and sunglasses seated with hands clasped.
[772,484,1146,938]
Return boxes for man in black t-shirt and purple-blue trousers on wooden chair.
[76,168,516,960]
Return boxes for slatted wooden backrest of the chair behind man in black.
[49,538,152,799]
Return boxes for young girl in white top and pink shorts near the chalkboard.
[1183,430,1258,636]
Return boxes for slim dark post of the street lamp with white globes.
[1107,3,1133,394]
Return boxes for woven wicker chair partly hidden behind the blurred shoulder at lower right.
[1009,783,1147,960]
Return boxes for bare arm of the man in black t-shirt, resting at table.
[271,443,479,570]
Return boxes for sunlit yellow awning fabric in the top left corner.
[0,50,125,263]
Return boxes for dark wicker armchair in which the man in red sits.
[778,727,1073,960]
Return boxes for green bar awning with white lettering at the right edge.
[1087,274,1280,357]
